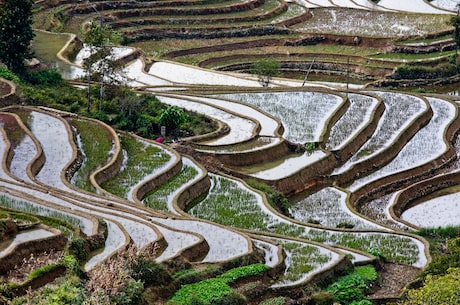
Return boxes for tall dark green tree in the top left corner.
[0,0,34,74]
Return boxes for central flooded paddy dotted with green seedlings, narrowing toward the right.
[189,176,419,264]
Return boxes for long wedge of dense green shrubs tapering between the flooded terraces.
[0,67,217,139]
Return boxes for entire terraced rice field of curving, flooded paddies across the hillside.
[0,0,460,304]
